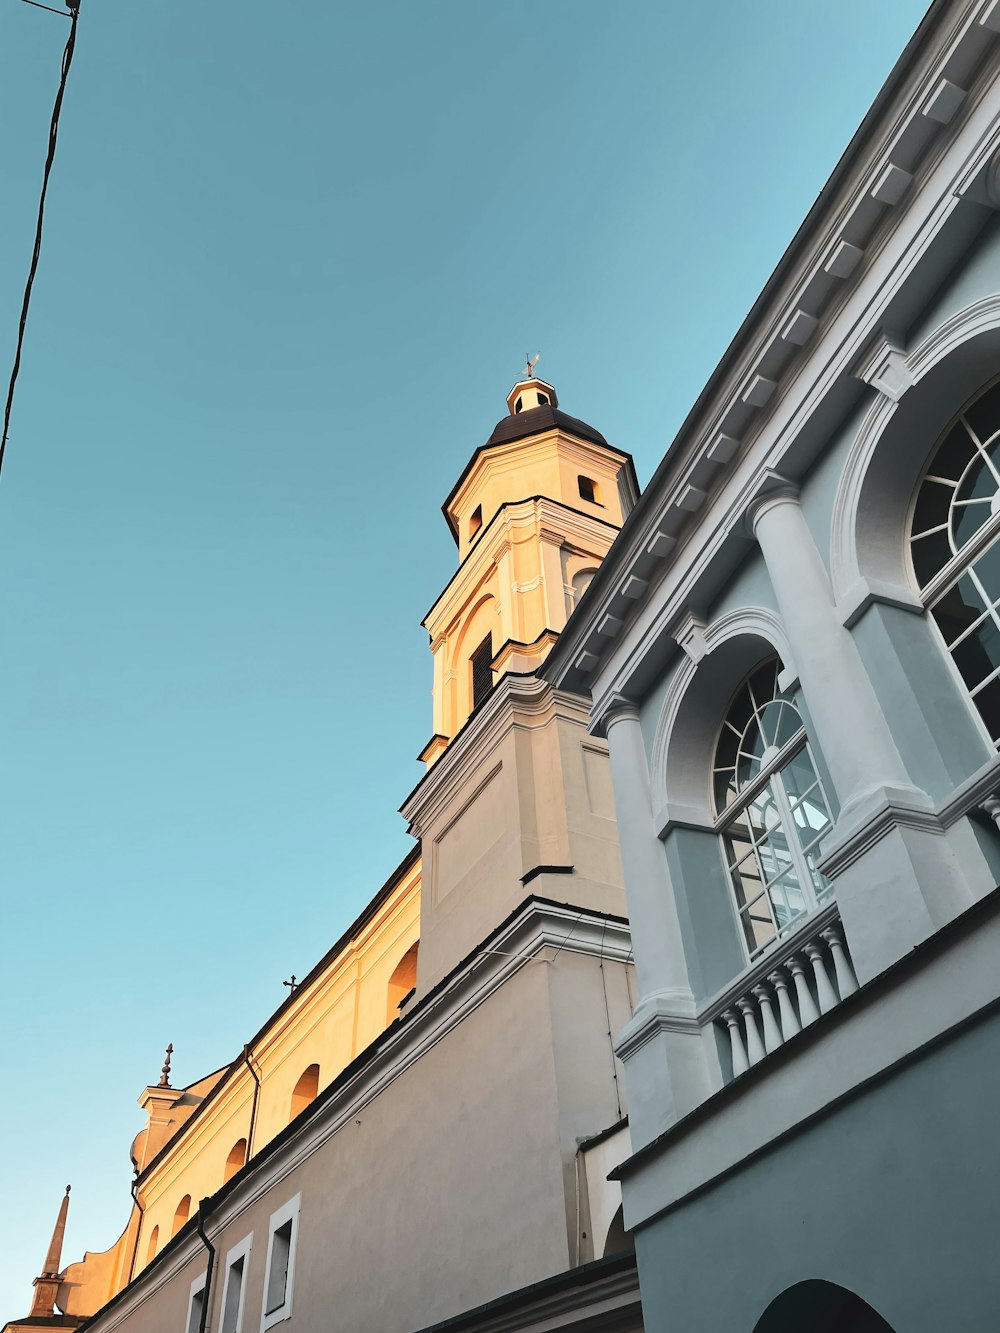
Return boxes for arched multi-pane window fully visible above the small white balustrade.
[713,657,832,961]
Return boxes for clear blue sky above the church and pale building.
[0,0,924,1321]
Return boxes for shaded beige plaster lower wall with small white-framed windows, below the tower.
[93,954,634,1333]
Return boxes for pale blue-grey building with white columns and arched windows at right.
[547,0,1000,1333]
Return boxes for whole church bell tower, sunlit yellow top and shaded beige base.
[403,367,639,996]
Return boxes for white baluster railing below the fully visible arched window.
[705,904,857,1078]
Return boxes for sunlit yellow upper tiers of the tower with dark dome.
[420,376,639,766]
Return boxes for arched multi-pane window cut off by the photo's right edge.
[909,381,1000,745]
